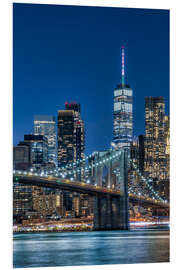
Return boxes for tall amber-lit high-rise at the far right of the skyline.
[144,97,169,197]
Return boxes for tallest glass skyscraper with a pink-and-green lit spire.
[113,47,133,148]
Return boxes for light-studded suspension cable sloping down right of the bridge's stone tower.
[130,160,168,203]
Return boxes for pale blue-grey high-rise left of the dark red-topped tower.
[34,115,57,166]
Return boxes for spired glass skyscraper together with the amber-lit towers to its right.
[112,47,170,199]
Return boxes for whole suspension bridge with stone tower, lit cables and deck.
[13,148,169,230]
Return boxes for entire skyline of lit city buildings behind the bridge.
[13,47,170,224]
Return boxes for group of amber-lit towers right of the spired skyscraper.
[126,97,170,200]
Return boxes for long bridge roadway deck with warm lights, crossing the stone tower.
[13,174,169,208]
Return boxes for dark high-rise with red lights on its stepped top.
[58,102,85,179]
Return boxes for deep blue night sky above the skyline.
[13,4,169,154]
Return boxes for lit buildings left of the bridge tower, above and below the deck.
[13,102,86,224]
